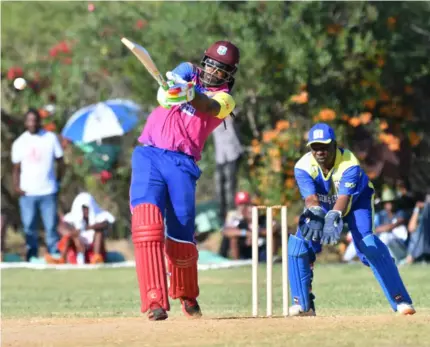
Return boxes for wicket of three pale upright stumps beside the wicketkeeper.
[252,205,289,317]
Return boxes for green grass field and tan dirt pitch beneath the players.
[2,265,430,347]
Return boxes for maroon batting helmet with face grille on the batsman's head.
[200,41,240,87]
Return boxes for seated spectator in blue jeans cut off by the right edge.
[402,194,430,264]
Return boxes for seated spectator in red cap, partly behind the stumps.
[218,192,279,261]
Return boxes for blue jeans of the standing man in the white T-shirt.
[19,194,59,261]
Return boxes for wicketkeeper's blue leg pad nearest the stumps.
[288,235,312,312]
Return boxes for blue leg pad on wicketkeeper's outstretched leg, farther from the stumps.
[360,235,412,311]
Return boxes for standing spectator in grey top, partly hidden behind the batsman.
[213,117,243,220]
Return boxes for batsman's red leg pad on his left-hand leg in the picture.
[131,204,170,313]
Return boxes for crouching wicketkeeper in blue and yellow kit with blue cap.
[288,123,415,316]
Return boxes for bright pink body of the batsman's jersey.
[139,76,232,161]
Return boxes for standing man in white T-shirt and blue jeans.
[12,109,64,261]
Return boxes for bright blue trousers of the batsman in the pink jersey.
[130,146,201,242]
